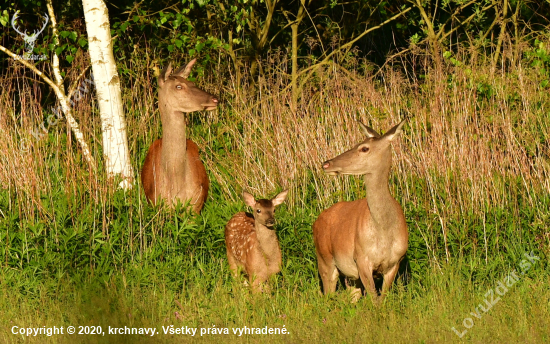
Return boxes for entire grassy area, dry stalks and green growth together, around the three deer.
[0,39,550,343]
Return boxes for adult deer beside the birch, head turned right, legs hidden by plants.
[141,59,218,213]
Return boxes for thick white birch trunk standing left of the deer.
[82,0,134,189]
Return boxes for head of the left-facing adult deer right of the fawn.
[323,121,405,176]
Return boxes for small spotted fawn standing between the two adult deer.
[225,190,288,292]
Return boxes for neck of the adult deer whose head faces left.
[365,166,399,229]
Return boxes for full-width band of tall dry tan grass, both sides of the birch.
[0,41,550,234]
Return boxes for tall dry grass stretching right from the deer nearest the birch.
[196,44,549,213]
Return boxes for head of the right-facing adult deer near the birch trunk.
[159,59,218,112]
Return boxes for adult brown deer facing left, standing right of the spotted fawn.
[313,121,409,303]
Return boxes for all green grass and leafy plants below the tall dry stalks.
[0,178,550,343]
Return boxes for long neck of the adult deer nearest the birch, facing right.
[159,98,187,181]
